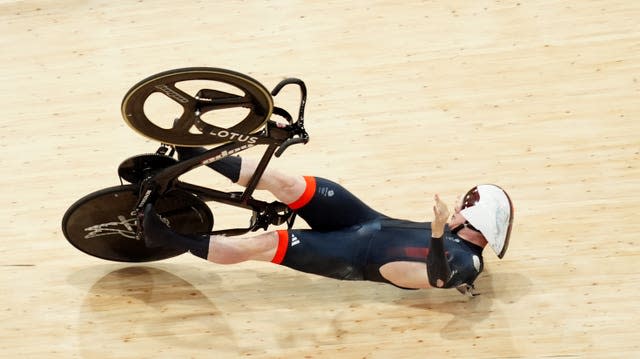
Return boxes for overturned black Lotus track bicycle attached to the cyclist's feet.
[62,67,309,262]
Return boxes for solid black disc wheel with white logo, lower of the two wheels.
[62,185,213,262]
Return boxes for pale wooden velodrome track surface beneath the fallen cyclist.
[0,0,640,358]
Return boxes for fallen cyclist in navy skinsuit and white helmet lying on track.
[143,147,513,294]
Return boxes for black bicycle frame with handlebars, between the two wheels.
[132,78,309,236]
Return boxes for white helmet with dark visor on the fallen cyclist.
[460,184,513,258]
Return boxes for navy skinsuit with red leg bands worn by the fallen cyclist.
[276,177,483,286]
